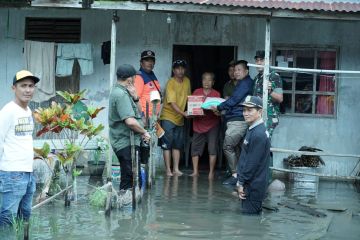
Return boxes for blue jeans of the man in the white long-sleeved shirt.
[0,171,36,227]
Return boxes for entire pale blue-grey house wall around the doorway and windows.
[0,9,360,174]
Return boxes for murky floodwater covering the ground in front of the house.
[2,173,360,240]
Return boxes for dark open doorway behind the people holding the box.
[173,45,237,170]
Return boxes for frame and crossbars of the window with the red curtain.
[272,44,340,118]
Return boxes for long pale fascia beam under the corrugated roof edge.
[21,0,360,21]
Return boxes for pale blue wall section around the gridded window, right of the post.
[272,19,360,174]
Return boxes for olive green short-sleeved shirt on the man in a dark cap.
[109,83,143,152]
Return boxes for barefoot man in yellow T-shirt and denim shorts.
[159,60,191,176]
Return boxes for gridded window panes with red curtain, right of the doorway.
[274,47,337,117]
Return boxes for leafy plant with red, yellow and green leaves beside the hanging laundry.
[34,89,104,204]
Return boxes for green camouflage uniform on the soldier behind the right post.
[254,72,283,139]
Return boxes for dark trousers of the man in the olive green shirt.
[116,146,142,190]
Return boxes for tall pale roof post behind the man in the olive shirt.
[106,11,119,182]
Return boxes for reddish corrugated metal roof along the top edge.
[141,0,360,12]
